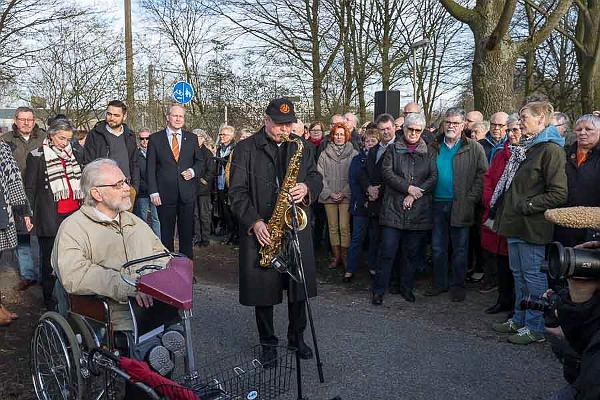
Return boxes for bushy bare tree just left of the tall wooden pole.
[20,15,125,129]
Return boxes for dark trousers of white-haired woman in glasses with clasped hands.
[373,226,428,294]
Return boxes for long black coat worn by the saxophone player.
[229,128,323,306]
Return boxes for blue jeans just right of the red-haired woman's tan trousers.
[346,215,379,273]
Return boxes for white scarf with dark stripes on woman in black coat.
[42,138,83,202]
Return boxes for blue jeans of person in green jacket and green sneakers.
[508,238,548,334]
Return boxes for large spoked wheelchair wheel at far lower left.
[31,312,82,400]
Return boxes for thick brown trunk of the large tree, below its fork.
[471,39,517,118]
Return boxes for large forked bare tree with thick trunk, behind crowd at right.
[440,0,572,115]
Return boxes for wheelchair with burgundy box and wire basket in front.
[30,252,302,400]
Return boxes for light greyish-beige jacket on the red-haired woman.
[317,142,358,204]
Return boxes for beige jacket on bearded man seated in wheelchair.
[52,205,167,330]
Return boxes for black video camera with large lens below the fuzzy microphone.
[542,242,600,280]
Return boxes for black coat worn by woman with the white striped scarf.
[24,147,79,237]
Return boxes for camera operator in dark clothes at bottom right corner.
[545,241,600,400]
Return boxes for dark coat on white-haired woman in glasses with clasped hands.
[379,137,438,230]
